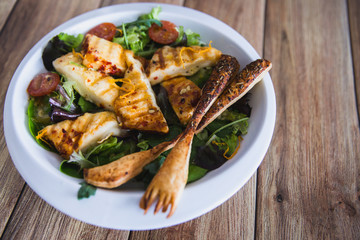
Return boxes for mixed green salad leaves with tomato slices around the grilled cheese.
[27,7,251,214]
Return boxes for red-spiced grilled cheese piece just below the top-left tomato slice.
[82,34,126,76]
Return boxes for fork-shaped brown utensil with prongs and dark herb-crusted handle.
[140,55,239,217]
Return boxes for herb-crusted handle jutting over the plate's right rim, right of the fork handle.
[196,59,272,132]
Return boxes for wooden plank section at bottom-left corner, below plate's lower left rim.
[2,186,129,240]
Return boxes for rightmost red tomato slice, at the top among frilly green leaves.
[149,20,179,44]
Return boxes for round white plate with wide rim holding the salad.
[4,3,276,230]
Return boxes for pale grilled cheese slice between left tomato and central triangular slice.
[53,53,121,111]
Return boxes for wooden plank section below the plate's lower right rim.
[129,174,256,240]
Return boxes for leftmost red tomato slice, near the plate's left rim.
[27,72,60,97]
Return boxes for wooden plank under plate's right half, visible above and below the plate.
[130,0,265,240]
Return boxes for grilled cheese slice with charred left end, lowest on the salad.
[37,112,124,159]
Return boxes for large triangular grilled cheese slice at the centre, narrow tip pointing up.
[114,50,169,133]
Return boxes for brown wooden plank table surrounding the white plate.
[0,0,360,239]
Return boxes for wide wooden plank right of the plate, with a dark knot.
[256,0,360,239]
